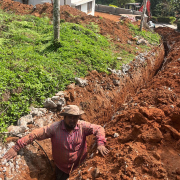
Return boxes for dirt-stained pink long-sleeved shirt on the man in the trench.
[14,120,106,174]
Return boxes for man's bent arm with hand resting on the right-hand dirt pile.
[80,121,109,156]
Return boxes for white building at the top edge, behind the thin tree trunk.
[14,0,95,15]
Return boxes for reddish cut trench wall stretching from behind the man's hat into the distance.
[66,44,164,125]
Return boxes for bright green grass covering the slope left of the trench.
[0,11,160,132]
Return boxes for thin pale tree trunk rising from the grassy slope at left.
[53,0,60,42]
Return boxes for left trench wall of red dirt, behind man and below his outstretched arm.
[0,44,164,180]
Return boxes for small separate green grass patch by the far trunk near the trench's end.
[129,24,161,44]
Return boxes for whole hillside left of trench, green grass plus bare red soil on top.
[0,1,159,131]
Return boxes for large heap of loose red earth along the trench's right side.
[70,28,180,180]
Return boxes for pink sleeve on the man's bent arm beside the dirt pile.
[80,121,106,146]
